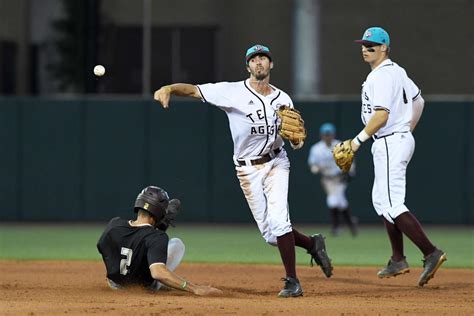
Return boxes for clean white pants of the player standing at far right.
[372,132,415,224]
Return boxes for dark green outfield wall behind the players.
[0,98,474,224]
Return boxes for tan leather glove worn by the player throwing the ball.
[277,105,306,145]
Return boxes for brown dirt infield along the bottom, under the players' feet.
[0,261,474,315]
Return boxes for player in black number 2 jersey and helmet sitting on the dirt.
[97,186,221,295]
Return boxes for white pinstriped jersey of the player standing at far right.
[361,59,421,137]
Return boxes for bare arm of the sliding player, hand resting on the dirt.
[150,263,222,296]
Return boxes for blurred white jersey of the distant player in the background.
[308,139,342,177]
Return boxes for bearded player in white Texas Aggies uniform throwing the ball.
[154,45,332,297]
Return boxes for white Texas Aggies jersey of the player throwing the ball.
[197,79,293,161]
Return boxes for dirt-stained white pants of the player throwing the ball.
[235,150,293,246]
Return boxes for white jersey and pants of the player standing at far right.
[361,59,421,223]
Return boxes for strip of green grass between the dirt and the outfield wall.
[0,224,474,268]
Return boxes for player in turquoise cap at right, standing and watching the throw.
[334,27,446,286]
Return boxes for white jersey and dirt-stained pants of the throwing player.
[197,79,293,245]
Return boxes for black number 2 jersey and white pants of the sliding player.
[97,217,184,288]
